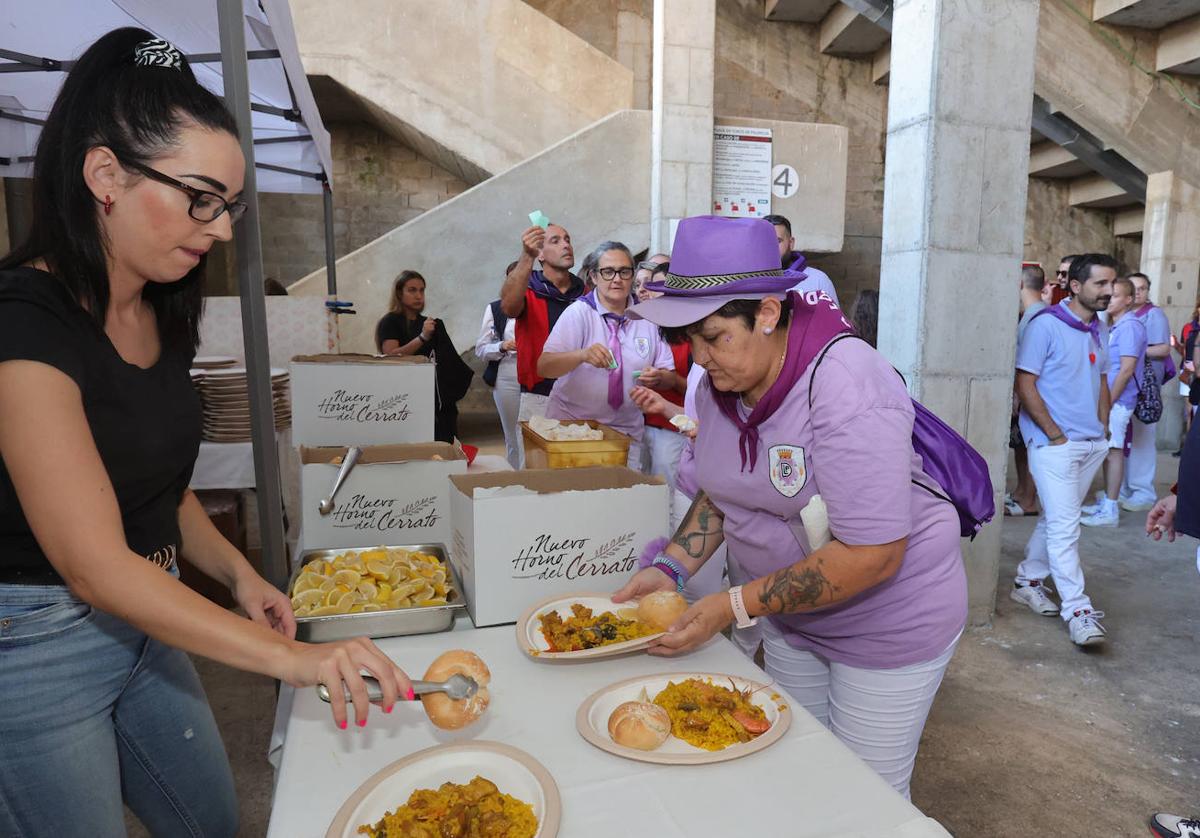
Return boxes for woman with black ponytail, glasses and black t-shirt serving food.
[0,29,412,838]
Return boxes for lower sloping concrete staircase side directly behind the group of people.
[288,110,650,353]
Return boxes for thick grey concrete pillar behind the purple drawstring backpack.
[878,0,1038,623]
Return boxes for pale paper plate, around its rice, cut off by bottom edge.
[325,741,563,838]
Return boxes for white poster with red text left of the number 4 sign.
[713,125,770,219]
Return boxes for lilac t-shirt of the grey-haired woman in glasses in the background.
[542,299,674,441]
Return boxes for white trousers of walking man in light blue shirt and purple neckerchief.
[1016,439,1109,621]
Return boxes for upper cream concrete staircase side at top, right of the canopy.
[292,0,634,188]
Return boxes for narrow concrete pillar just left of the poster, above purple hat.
[650,0,716,253]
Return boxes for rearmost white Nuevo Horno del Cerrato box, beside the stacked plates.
[290,355,434,445]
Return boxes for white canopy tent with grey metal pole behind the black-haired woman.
[0,0,336,586]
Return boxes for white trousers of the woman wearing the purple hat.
[758,618,961,797]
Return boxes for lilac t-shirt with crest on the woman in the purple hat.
[696,340,967,669]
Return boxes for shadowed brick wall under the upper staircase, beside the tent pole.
[260,122,467,285]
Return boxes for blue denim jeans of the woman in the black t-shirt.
[0,585,238,838]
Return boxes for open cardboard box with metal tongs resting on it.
[300,442,467,550]
